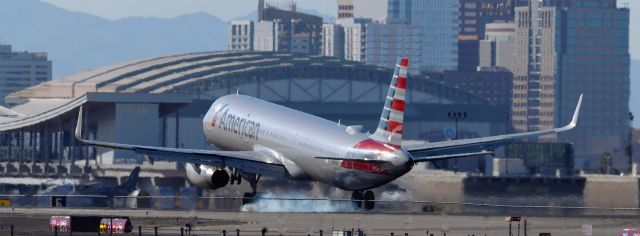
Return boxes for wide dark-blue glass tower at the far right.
[557,0,630,170]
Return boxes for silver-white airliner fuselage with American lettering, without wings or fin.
[203,95,413,190]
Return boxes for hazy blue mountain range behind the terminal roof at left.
[0,0,226,79]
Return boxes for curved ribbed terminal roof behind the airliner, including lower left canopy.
[0,52,487,131]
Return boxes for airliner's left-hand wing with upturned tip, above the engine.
[75,107,288,178]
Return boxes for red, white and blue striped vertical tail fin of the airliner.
[371,56,409,147]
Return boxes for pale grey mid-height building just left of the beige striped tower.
[478,23,516,70]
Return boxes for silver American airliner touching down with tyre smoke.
[75,57,582,210]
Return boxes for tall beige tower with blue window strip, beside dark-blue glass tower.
[512,0,562,135]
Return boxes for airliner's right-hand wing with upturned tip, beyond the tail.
[403,95,582,162]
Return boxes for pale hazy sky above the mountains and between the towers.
[42,0,640,59]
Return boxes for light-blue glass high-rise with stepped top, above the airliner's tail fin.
[387,0,459,71]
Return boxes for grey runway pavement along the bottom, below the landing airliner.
[0,208,640,236]
